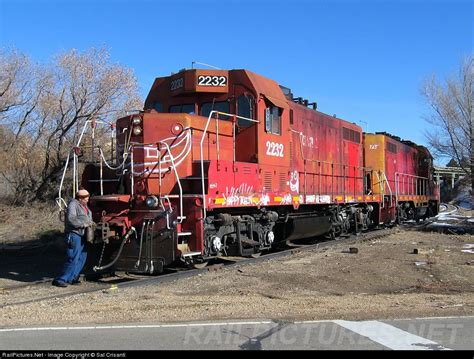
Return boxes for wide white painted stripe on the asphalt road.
[334,320,450,350]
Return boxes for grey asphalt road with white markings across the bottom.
[0,316,474,350]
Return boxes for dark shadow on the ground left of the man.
[0,231,66,283]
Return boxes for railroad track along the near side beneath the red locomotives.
[0,227,397,308]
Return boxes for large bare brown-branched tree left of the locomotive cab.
[0,49,142,202]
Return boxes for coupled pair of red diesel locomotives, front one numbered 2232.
[60,69,439,274]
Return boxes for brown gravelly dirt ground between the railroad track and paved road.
[0,229,474,327]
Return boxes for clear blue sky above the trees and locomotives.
[0,0,473,162]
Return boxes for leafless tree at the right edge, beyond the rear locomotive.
[421,56,474,193]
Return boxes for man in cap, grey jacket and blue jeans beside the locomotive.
[52,189,93,287]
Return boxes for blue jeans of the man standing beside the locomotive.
[56,233,87,283]
